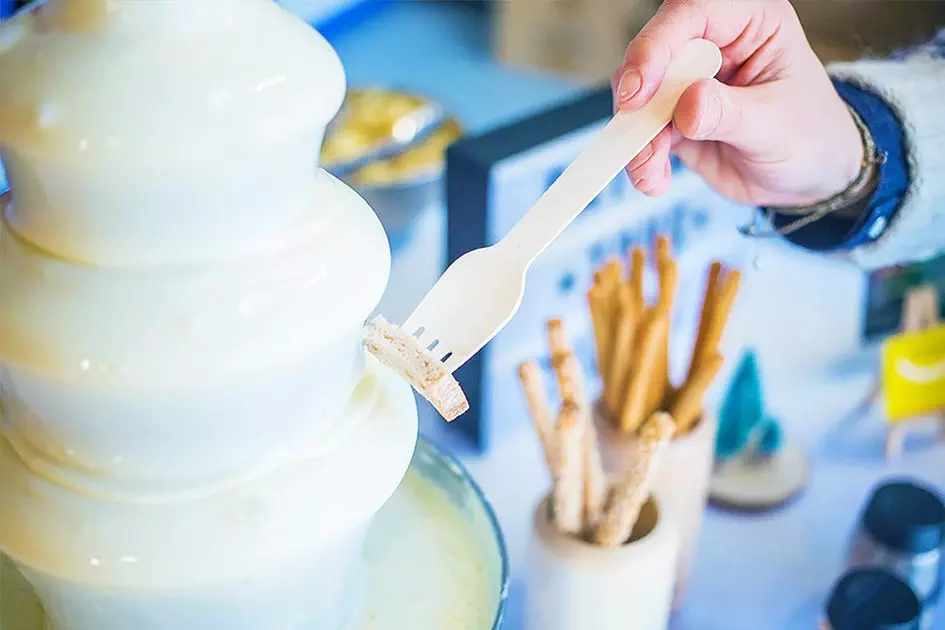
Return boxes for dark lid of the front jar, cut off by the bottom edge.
[827,567,922,630]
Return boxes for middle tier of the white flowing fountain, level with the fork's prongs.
[0,174,390,484]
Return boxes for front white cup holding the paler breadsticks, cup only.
[525,498,679,630]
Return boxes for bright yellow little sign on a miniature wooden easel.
[882,325,945,422]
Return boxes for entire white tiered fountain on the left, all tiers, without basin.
[0,0,506,630]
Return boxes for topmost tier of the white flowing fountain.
[0,0,345,266]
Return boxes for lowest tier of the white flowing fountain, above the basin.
[0,360,417,630]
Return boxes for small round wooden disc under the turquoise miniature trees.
[709,443,807,512]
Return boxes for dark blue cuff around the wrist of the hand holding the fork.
[772,81,909,252]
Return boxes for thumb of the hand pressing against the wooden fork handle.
[673,79,772,149]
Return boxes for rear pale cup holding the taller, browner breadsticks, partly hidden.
[594,405,718,608]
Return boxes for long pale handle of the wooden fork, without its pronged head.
[500,39,722,267]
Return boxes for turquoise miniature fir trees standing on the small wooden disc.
[715,350,784,460]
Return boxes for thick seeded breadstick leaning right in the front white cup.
[594,412,676,547]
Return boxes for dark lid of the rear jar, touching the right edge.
[863,481,945,553]
